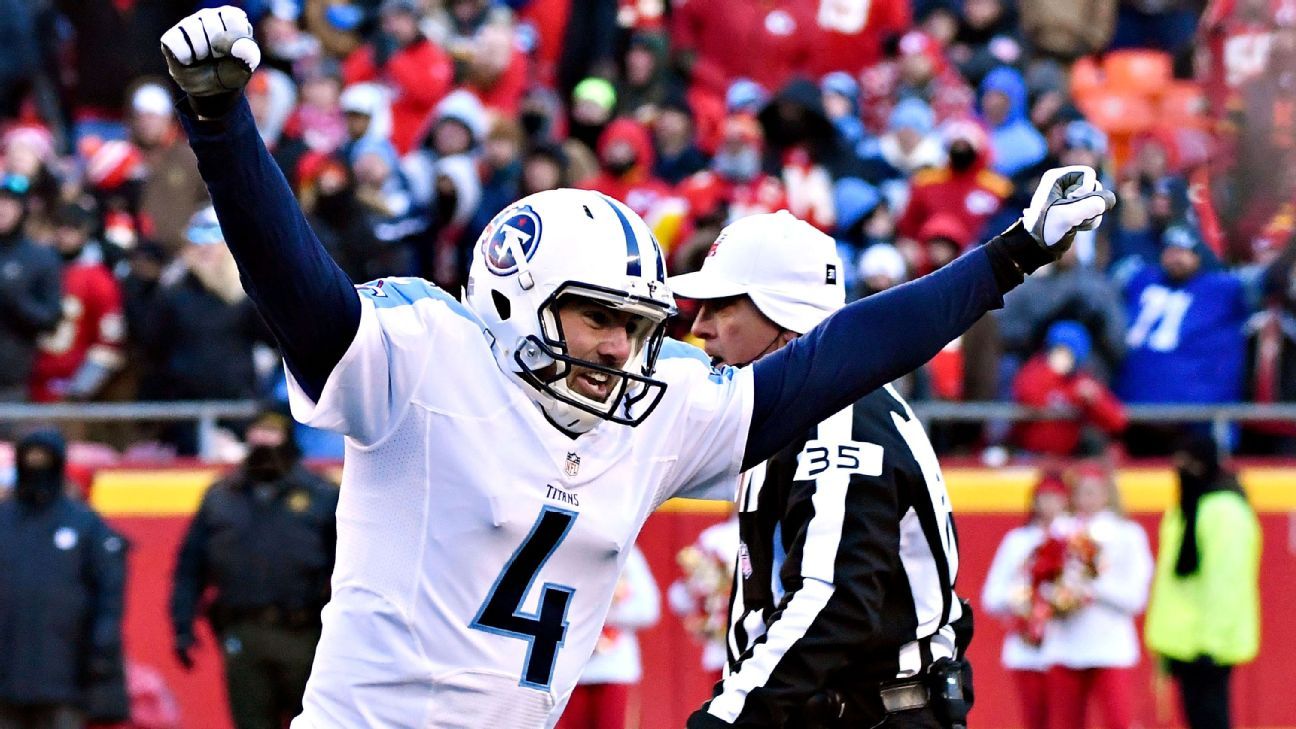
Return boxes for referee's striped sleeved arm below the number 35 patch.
[687,463,899,729]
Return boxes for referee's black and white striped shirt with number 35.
[688,387,962,728]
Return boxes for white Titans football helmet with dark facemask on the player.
[464,189,675,433]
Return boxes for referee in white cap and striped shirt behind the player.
[670,213,971,729]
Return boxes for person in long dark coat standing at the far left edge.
[0,431,127,729]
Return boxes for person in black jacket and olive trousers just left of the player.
[171,412,337,729]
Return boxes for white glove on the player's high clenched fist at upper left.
[162,5,260,97]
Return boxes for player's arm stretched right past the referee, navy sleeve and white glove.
[743,167,1116,468]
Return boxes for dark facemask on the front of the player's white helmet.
[515,281,674,432]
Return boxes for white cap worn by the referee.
[669,210,846,335]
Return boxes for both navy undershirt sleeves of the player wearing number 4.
[181,100,1021,459]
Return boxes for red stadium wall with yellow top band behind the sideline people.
[93,464,1296,729]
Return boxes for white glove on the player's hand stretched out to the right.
[1021,165,1116,256]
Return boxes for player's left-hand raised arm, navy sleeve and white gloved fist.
[162,6,360,400]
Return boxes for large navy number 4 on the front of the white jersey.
[469,506,577,690]
